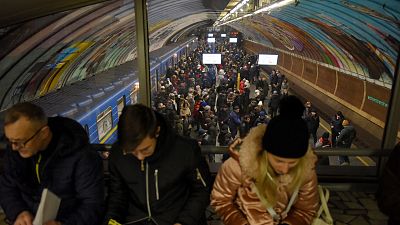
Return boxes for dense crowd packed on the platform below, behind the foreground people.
[150,38,289,149]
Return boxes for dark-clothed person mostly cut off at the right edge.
[376,143,400,225]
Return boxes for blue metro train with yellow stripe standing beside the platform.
[27,38,197,144]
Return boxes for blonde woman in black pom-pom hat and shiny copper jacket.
[210,96,319,225]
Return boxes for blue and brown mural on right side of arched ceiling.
[228,0,400,87]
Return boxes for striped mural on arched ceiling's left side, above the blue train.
[0,0,226,108]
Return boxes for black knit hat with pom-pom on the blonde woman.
[262,96,310,159]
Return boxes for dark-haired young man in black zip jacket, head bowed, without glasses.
[106,104,209,225]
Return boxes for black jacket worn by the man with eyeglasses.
[0,117,104,225]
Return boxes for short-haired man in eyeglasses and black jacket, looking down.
[0,103,104,225]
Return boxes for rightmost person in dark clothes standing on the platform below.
[336,119,357,166]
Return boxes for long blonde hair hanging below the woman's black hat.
[254,148,314,207]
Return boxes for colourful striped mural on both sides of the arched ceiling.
[0,0,400,108]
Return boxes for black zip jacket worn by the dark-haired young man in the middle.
[105,113,209,225]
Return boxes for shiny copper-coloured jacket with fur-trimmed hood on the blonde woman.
[211,125,319,225]
